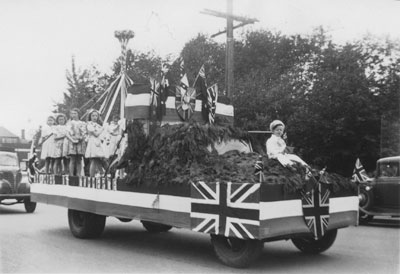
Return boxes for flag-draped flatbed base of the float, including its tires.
[31,174,359,267]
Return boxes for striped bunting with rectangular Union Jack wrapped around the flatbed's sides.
[31,178,358,239]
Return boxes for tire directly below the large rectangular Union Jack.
[211,234,264,268]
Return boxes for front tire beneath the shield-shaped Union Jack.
[292,229,337,254]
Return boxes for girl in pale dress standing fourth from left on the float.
[85,110,105,177]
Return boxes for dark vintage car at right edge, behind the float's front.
[359,156,400,223]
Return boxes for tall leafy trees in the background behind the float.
[57,28,400,176]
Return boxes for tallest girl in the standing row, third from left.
[65,108,86,176]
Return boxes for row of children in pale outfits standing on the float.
[39,108,124,176]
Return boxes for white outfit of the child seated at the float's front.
[266,134,307,166]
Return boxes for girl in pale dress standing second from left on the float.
[53,113,68,174]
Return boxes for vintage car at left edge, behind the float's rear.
[0,147,36,213]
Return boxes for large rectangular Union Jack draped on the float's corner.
[190,182,260,239]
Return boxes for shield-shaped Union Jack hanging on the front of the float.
[301,184,330,239]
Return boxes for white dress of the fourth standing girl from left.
[85,121,105,158]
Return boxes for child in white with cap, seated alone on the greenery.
[266,120,308,167]
